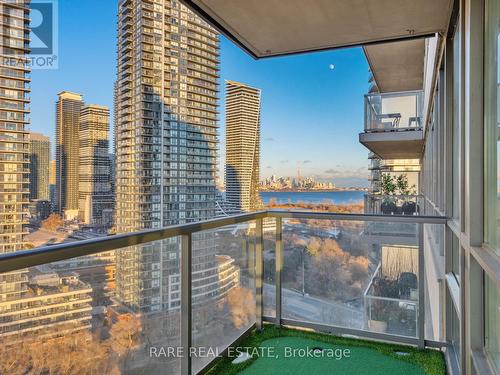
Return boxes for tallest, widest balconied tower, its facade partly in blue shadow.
[115,0,219,313]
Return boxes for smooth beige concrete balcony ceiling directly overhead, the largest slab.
[182,0,453,57]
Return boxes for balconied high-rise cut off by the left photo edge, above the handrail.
[0,2,30,253]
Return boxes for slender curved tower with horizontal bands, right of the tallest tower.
[225,81,261,211]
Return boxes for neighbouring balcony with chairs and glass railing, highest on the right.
[359,91,424,159]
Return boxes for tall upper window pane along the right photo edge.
[484,0,500,253]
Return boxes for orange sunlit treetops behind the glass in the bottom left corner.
[0,314,145,375]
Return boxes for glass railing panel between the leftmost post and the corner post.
[191,221,256,373]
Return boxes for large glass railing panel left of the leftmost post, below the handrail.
[0,242,180,374]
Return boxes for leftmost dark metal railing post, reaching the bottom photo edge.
[181,234,192,375]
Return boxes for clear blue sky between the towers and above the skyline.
[31,0,368,186]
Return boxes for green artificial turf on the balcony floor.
[208,325,445,375]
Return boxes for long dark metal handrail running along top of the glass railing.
[0,209,447,273]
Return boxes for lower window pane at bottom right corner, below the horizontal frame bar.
[484,276,500,373]
